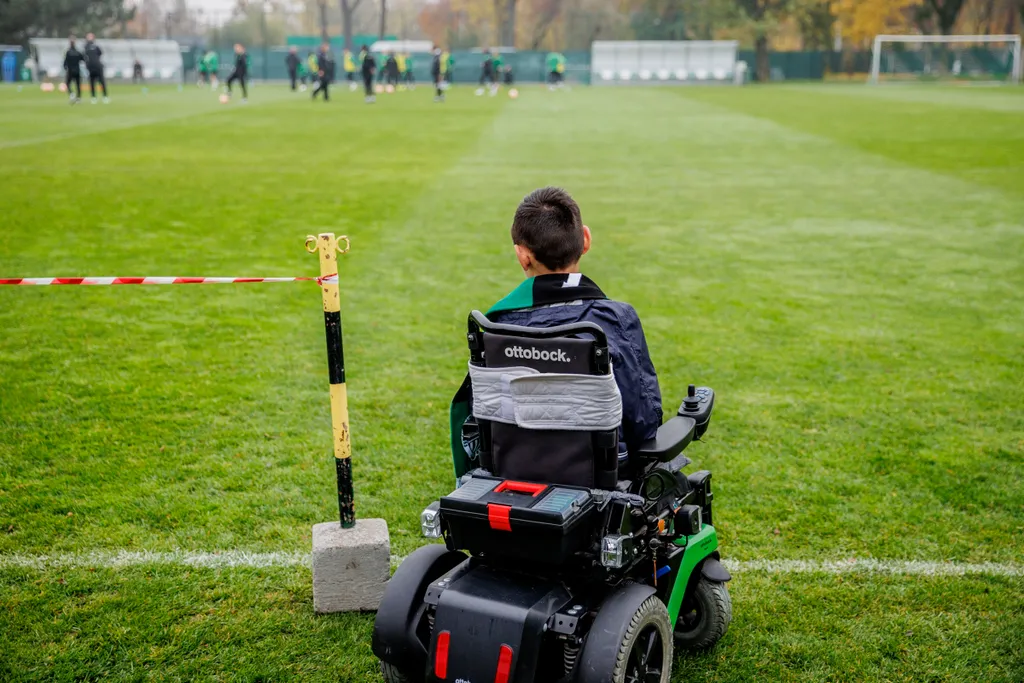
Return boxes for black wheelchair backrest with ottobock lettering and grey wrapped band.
[468,310,622,488]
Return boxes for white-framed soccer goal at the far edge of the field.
[870,35,1021,83]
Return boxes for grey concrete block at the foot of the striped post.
[313,519,391,614]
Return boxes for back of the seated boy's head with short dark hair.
[512,187,584,270]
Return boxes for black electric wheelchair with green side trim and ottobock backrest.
[373,311,732,683]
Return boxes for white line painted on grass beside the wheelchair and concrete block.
[0,550,1024,577]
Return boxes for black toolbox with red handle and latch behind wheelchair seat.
[440,476,595,564]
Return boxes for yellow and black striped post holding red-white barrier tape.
[306,232,355,528]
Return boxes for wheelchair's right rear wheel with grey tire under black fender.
[575,584,673,683]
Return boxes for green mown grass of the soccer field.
[0,85,1024,681]
